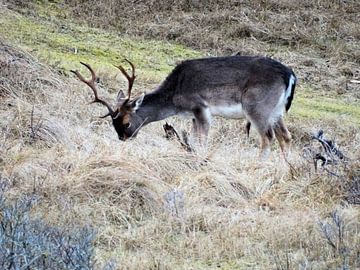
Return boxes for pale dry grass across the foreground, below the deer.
[0,39,360,269]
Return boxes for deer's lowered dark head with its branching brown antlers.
[71,59,145,141]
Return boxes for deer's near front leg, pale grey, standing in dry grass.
[193,106,211,145]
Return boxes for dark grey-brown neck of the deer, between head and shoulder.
[136,91,177,125]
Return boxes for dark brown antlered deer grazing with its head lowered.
[71,55,297,159]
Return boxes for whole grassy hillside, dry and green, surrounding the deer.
[0,0,360,269]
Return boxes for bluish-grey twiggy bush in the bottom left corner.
[0,188,95,269]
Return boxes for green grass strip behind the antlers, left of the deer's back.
[0,4,202,81]
